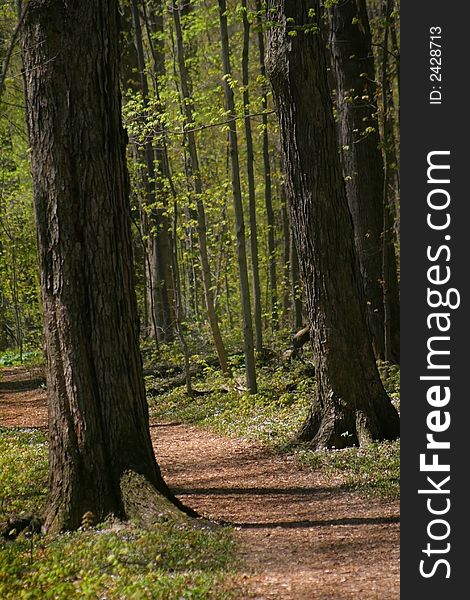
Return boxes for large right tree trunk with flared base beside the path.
[267,0,399,448]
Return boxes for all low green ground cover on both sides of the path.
[0,349,400,600]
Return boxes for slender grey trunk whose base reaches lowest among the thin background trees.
[219,0,257,394]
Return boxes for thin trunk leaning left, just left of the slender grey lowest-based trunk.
[173,5,230,375]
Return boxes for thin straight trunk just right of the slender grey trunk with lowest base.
[242,0,263,352]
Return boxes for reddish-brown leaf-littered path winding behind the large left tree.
[0,367,399,600]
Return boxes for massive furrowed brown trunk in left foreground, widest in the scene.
[22,0,191,530]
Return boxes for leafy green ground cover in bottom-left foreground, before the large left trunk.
[0,521,234,600]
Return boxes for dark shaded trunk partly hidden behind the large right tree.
[330,0,400,362]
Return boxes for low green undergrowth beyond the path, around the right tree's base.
[147,353,400,499]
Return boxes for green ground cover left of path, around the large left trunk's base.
[0,429,234,600]
